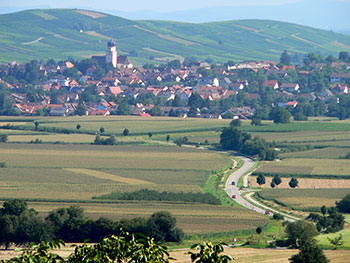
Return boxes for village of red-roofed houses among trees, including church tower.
[0,40,350,120]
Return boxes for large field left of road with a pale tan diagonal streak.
[0,144,231,200]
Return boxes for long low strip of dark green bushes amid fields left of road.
[94,189,221,205]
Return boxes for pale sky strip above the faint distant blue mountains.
[0,0,312,12]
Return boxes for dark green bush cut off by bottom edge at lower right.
[289,239,329,263]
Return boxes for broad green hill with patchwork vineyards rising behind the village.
[0,9,350,64]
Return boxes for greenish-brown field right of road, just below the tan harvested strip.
[259,188,350,208]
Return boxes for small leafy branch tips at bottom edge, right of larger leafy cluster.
[188,242,234,263]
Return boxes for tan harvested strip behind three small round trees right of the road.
[249,176,350,189]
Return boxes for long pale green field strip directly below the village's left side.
[0,116,230,135]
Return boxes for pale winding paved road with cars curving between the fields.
[225,156,298,221]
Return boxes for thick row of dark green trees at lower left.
[0,200,184,248]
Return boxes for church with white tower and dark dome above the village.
[92,39,134,68]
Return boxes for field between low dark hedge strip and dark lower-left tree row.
[15,201,268,234]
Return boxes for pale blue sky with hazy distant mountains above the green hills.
[0,0,350,33]
